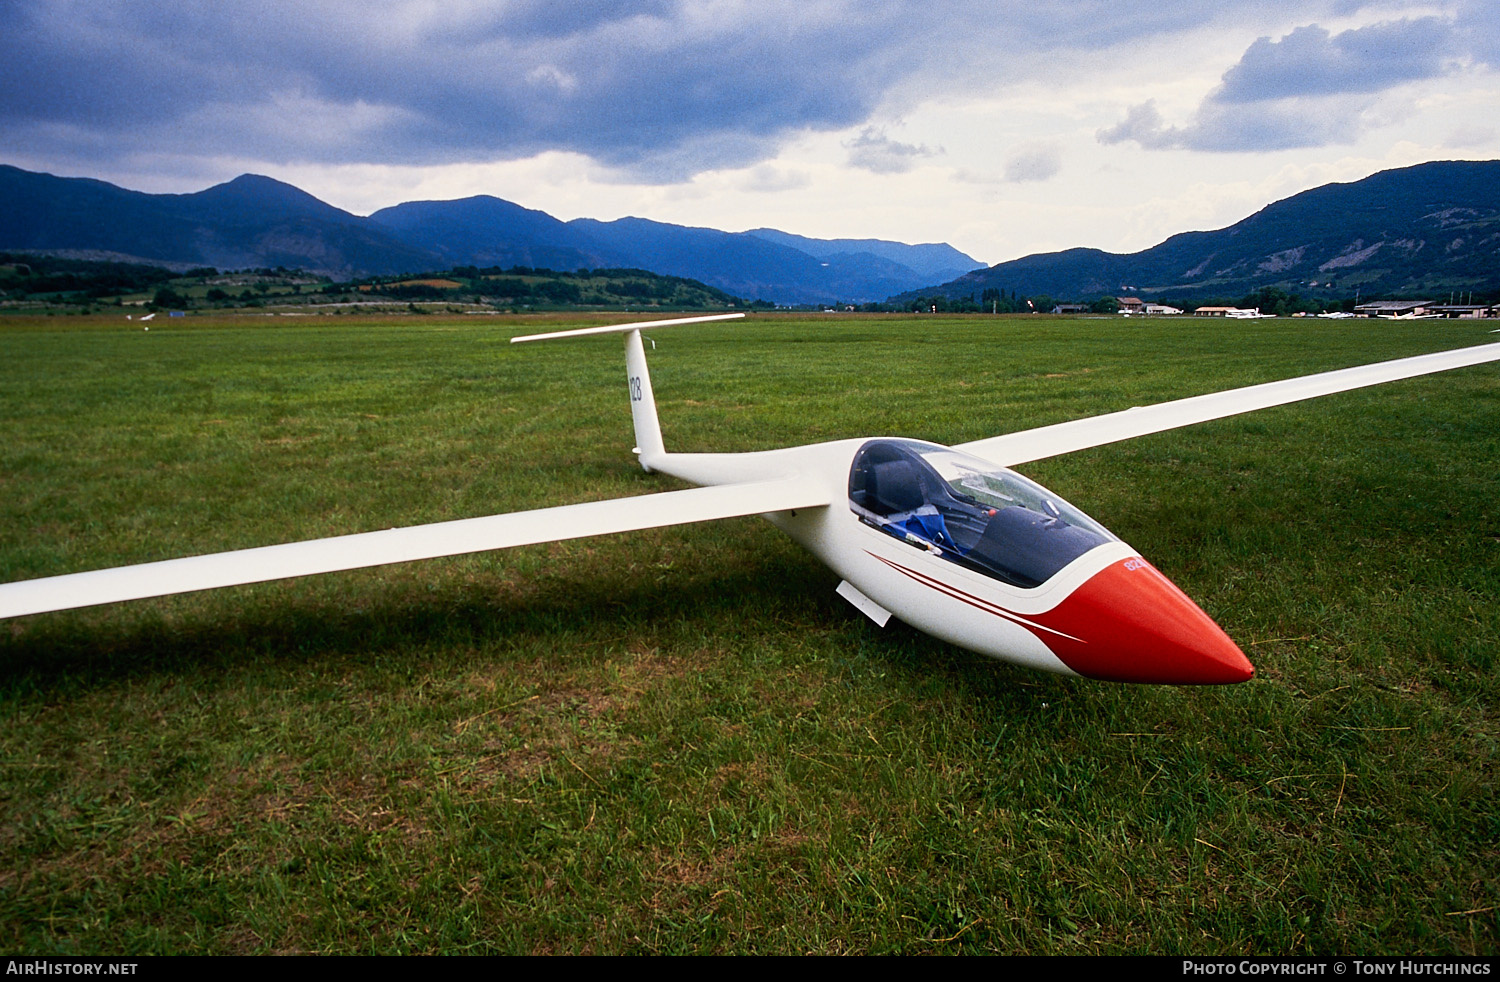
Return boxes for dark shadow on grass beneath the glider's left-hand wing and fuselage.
[0,538,1079,728]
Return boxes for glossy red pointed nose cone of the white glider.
[1037,558,1256,685]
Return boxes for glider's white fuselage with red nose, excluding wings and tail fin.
[641,438,1254,684]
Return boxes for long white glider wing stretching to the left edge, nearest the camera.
[0,478,828,618]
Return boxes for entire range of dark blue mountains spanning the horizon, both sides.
[0,160,1500,304]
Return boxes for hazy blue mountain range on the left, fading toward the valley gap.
[0,165,981,303]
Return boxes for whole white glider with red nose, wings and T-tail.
[0,313,1500,685]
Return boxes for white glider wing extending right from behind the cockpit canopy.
[954,345,1500,466]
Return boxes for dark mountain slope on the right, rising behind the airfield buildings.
[900,160,1500,300]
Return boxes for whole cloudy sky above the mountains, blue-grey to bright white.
[0,0,1500,262]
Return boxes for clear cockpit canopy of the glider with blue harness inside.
[849,439,1118,588]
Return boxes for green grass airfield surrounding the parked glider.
[0,316,1500,955]
